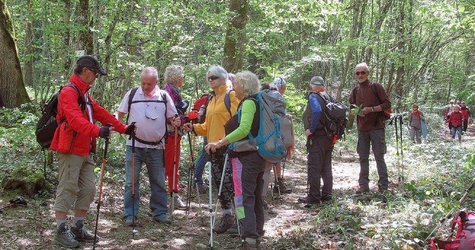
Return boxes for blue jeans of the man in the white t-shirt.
[124,146,168,218]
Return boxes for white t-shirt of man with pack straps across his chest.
[118,87,177,149]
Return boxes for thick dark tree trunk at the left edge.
[0,0,30,107]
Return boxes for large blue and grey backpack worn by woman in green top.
[249,89,293,163]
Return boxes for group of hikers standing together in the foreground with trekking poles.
[50,55,391,249]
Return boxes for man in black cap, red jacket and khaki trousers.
[50,55,135,248]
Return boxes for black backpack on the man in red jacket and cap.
[35,83,86,149]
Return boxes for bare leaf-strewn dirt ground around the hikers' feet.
[0,126,473,249]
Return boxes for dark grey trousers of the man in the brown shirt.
[356,129,389,189]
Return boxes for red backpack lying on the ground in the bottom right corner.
[430,211,475,250]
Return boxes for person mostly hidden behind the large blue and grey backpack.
[262,77,292,202]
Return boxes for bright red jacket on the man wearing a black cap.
[50,74,127,155]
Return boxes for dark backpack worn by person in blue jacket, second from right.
[313,92,348,141]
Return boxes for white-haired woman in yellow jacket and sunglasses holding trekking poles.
[184,65,239,234]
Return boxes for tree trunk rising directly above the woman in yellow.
[223,0,249,72]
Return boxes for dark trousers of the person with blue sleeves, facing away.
[307,135,333,203]
